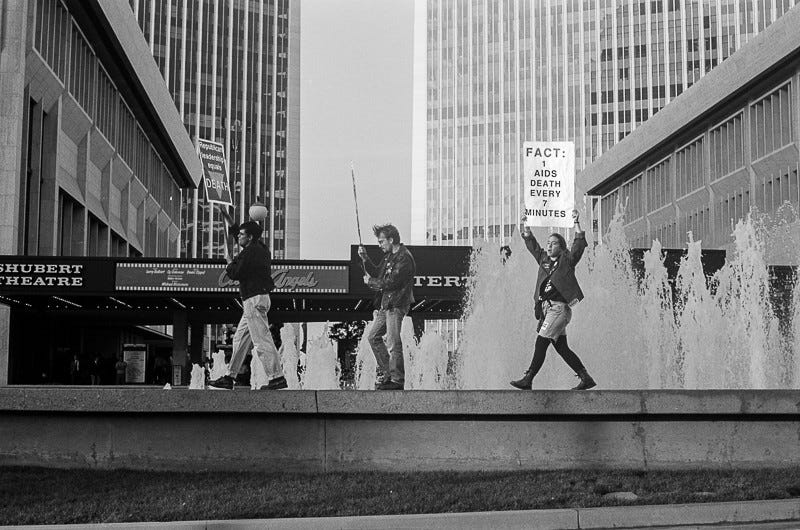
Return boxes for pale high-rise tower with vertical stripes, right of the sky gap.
[412,0,796,245]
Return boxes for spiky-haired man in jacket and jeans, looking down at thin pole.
[358,224,417,390]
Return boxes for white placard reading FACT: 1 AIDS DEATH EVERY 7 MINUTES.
[522,142,575,227]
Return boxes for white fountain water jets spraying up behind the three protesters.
[212,202,800,390]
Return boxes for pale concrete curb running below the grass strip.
[14,498,800,530]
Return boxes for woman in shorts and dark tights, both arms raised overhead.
[511,210,597,390]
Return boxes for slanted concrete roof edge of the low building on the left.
[65,0,202,188]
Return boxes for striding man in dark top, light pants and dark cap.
[209,221,288,390]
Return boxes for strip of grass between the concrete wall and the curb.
[0,467,800,525]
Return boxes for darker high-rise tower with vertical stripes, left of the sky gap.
[129,0,300,259]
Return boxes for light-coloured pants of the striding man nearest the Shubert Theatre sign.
[228,294,283,379]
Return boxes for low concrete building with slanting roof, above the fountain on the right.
[579,3,800,252]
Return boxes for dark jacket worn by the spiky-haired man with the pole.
[364,244,417,309]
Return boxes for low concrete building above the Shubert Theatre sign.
[0,0,200,384]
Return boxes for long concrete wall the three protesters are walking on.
[0,387,800,471]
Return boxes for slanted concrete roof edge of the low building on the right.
[578,5,800,195]
